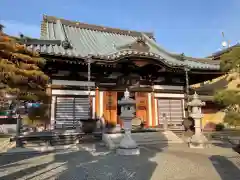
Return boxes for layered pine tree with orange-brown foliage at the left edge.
[0,25,49,107]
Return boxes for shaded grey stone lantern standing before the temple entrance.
[117,89,140,155]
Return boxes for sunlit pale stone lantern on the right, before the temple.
[187,92,207,148]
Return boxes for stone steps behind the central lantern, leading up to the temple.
[102,131,183,149]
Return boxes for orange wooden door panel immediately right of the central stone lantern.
[135,92,148,124]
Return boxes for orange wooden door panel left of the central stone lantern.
[103,91,117,125]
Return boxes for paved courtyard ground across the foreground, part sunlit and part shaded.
[0,144,240,180]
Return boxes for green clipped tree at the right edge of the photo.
[214,47,240,126]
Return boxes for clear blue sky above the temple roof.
[0,0,240,57]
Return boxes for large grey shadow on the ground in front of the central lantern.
[55,143,160,180]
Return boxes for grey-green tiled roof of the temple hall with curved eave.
[23,16,220,70]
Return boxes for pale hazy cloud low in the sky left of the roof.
[0,20,41,38]
